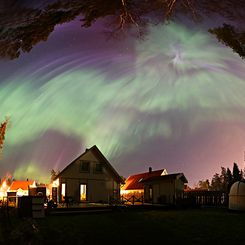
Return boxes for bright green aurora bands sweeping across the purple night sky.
[0,23,245,184]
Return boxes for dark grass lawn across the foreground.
[1,208,245,245]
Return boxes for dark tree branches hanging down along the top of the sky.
[0,0,245,59]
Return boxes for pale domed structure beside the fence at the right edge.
[229,181,245,210]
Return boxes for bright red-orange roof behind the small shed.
[122,169,167,190]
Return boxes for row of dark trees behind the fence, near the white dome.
[196,163,245,193]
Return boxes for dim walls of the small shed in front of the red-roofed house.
[144,179,184,204]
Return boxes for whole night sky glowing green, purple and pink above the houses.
[0,17,245,184]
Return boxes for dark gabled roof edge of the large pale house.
[55,145,123,183]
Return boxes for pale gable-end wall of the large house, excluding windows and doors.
[58,151,120,202]
